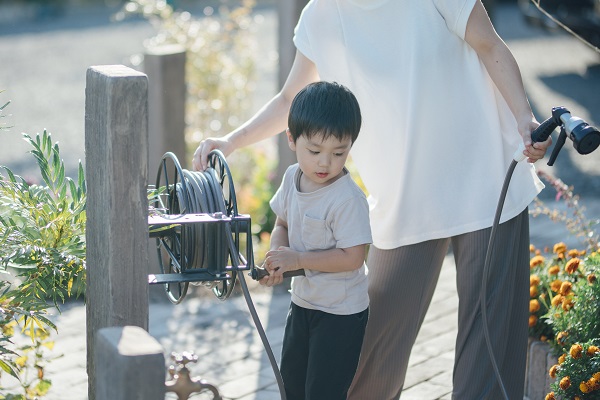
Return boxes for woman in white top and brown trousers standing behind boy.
[194,0,550,400]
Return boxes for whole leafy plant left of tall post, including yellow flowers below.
[0,131,86,400]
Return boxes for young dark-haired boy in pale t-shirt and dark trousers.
[260,82,372,400]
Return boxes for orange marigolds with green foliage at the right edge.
[529,170,600,400]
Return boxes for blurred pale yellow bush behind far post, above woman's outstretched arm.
[115,0,256,146]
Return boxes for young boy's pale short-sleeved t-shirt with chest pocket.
[270,164,372,315]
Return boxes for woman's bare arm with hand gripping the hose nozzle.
[465,0,552,162]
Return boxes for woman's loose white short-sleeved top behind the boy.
[294,0,543,249]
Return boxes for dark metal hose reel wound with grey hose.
[148,150,254,304]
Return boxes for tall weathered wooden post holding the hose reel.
[85,65,148,400]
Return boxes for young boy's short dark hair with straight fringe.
[288,82,362,143]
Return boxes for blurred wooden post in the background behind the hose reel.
[144,45,188,179]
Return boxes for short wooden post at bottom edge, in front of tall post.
[95,326,166,400]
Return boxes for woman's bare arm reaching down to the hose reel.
[192,51,319,170]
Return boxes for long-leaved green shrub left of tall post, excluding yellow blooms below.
[0,131,86,307]
